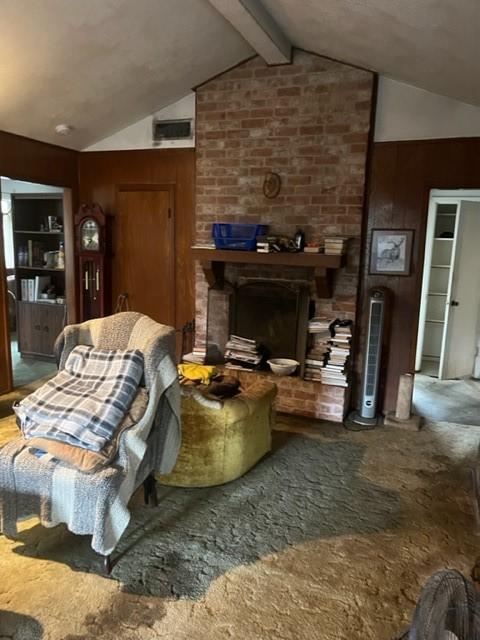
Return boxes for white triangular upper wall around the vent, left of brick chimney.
[83,92,195,151]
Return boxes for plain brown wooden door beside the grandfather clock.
[112,185,175,326]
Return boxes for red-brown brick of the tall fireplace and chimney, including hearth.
[196,50,374,421]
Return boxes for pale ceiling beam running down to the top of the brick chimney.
[209,0,292,64]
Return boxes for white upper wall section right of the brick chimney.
[375,76,480,142]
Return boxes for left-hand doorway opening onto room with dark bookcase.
[0,176,66,389]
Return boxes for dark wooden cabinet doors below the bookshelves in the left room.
[17,302,65,359]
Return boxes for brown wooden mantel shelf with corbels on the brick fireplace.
[192,247,345,298]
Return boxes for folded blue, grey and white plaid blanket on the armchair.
[14,345,143,451]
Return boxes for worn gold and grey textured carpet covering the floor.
[0,420,480,640]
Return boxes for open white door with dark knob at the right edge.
[439,200,480,379]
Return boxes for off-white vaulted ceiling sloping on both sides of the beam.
[0,0,480,148]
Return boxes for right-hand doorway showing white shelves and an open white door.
[414,190,480,425]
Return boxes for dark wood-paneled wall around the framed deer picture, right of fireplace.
[357,138,480,411]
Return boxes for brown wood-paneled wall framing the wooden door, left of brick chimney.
[79,149,195,338]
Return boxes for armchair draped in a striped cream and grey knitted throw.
[0,312,180,569]
